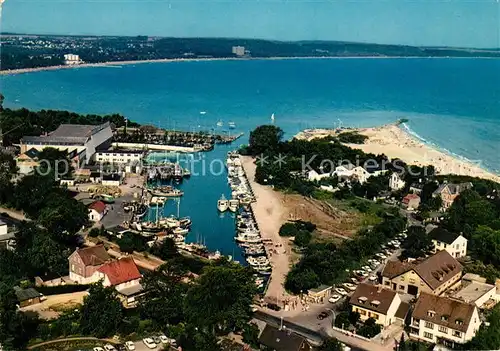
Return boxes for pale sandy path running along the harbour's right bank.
[241,156,291,299]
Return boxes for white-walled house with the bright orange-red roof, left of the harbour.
[93,257,144,308]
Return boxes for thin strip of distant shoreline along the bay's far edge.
[0,56,500,76]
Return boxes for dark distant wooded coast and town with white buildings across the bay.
[0,33,500,70]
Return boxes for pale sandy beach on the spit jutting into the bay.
[296,124,500,182]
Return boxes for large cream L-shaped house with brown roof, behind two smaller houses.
[382,250,462,296]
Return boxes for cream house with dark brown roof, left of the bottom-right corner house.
[349,283,401,327]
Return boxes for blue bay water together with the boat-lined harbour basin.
[1,58,500,259]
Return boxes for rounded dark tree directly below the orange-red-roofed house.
[80,282,123,338]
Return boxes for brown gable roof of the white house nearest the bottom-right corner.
[413,292,476,332]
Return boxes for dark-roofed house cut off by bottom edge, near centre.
[259,324,312,351]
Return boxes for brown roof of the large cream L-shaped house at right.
[382,250,462,290]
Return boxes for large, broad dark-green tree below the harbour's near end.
[184,264,256,334]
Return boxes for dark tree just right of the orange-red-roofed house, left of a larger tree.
[139,262,187,328]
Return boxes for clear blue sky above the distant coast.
[1,0,500,48]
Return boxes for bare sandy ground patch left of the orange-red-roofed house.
[21,291,88,319]
